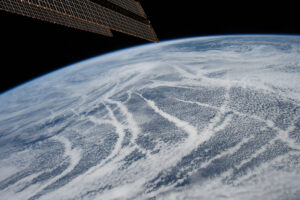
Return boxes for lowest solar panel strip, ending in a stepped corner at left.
[0,0,112,36]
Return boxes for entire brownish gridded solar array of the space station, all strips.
[0,0,158,42]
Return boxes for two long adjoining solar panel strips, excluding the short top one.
[0,0,157,41]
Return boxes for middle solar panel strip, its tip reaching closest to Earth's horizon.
[23,0,157,41]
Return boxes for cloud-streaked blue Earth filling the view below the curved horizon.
[0,35,300,200]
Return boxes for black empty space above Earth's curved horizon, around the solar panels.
[0,0,300,93]
